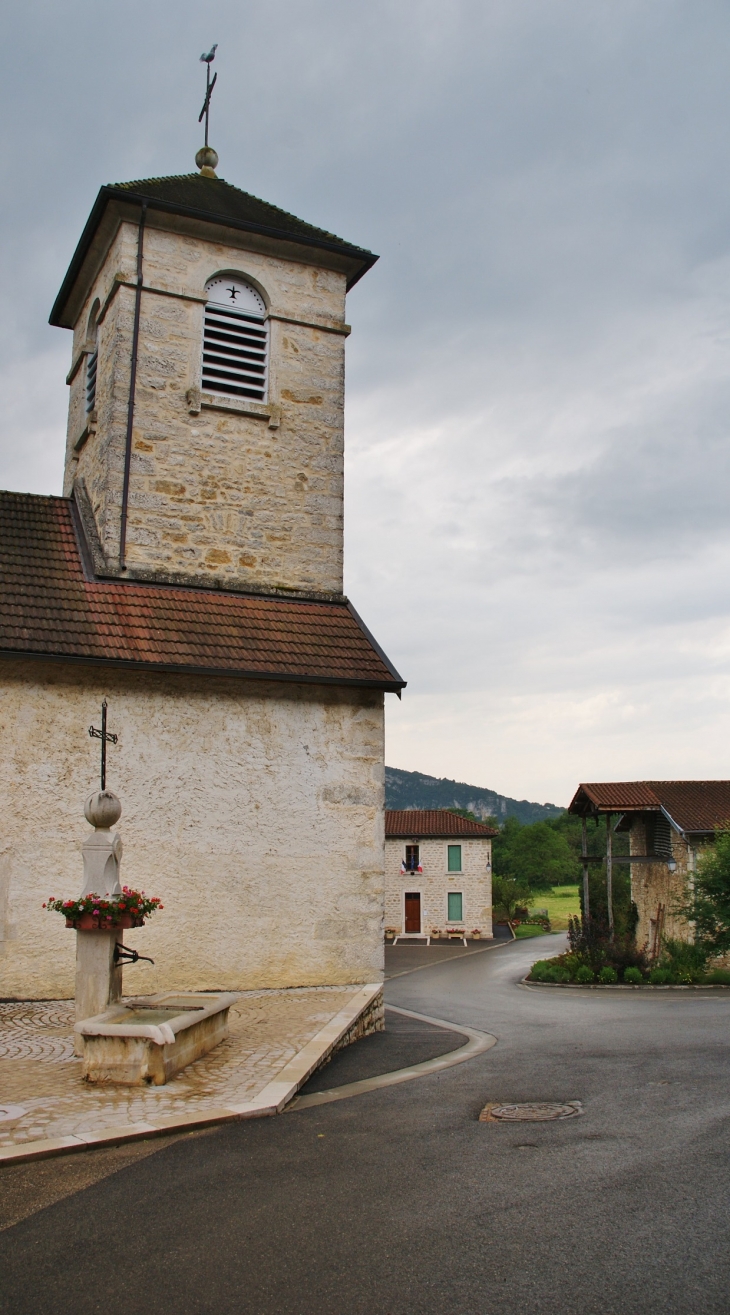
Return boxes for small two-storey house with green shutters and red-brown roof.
[385,809,497,940]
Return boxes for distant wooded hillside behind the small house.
[385,767,563,823]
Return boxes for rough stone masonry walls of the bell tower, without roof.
[64,219,347,594]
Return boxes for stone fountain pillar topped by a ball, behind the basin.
[76,790,122,1053]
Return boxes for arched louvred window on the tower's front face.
[203,275,268,402]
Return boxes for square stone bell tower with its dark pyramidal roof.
[50,151,377,597]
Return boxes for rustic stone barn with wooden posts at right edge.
[570,781,730,953]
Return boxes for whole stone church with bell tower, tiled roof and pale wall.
[0,159,404,998]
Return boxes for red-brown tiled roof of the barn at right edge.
[570,781,730,832]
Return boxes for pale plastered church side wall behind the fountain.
[0,661,384,998]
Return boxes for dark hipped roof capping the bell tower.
[50,174,377,327]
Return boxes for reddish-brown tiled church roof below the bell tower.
[0,493,404,690]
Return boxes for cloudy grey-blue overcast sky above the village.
[0,0,730,803]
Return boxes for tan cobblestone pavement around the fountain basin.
[0,986,360,1147]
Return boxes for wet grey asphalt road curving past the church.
[0,938,730,1315]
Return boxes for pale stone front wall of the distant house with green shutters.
[385,836,492,936]
